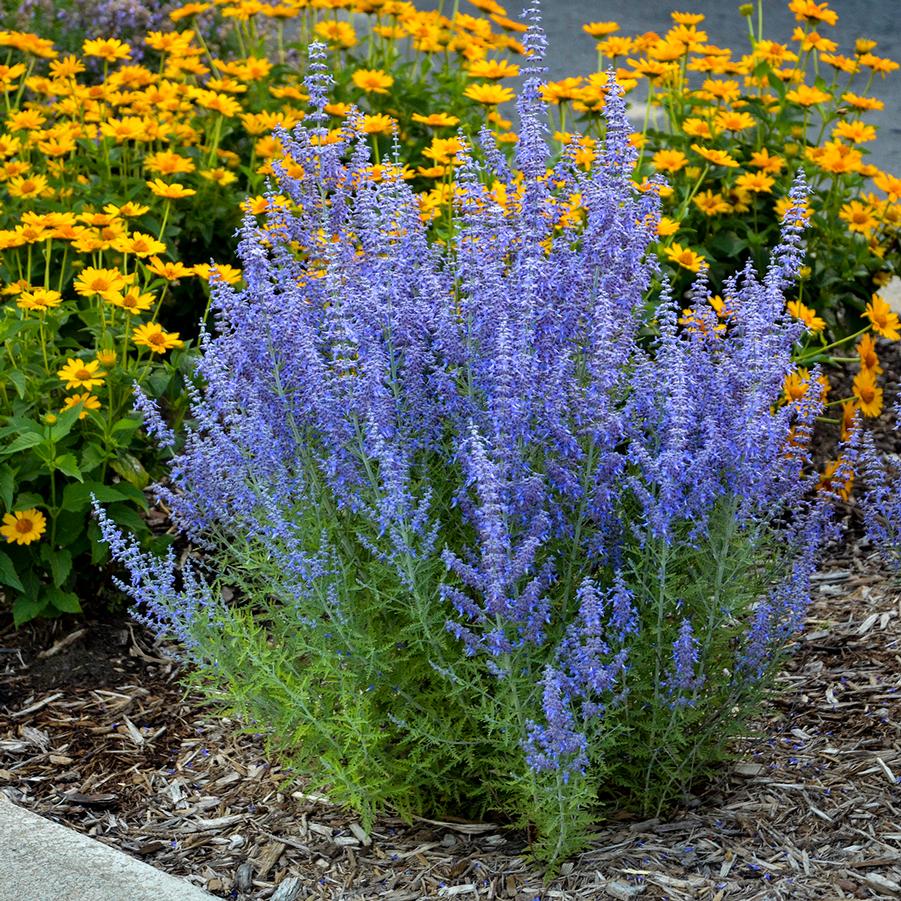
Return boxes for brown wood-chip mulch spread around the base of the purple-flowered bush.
[0,528,901,901]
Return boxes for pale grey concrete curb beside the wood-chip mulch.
[0,791,214,901]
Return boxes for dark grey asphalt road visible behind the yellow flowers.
[416,0,901,174]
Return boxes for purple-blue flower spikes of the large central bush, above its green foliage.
[110,27,829,796]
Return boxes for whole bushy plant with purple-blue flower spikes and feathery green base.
[101,28,847,866]
